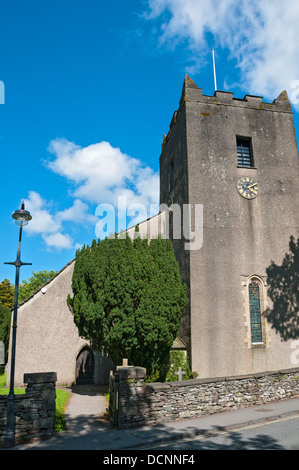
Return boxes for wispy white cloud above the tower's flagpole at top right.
[146,0,299,98]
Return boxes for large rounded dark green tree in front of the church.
[68,236,187,374]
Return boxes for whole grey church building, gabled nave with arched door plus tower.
[8,75,299,385]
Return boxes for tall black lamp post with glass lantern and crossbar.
[4,202,32,447]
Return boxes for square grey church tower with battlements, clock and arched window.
[160,75,299,377]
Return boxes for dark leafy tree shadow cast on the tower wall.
[265,236,299,341]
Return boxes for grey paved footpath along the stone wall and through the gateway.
[5,385,299,450]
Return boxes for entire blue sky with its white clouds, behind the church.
[0,0,299,282]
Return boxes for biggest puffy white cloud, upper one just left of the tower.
[47,139,159,207]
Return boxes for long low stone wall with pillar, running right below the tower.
[118,367,299,429]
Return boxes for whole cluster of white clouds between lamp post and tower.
[21,139,159,250]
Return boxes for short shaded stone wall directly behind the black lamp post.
[0,372,57,447]
